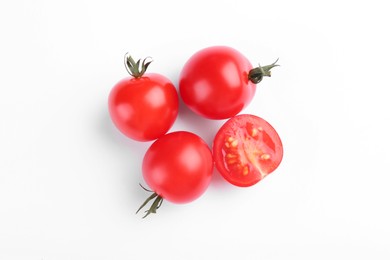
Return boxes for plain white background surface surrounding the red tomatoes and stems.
[0,0,390,260]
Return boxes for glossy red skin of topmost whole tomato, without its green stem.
[179,46,256,119]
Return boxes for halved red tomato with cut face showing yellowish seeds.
[213,114,283,187]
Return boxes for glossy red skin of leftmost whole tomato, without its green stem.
[108,73,179,141]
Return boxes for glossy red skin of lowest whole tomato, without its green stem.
[142,131,213,203]
